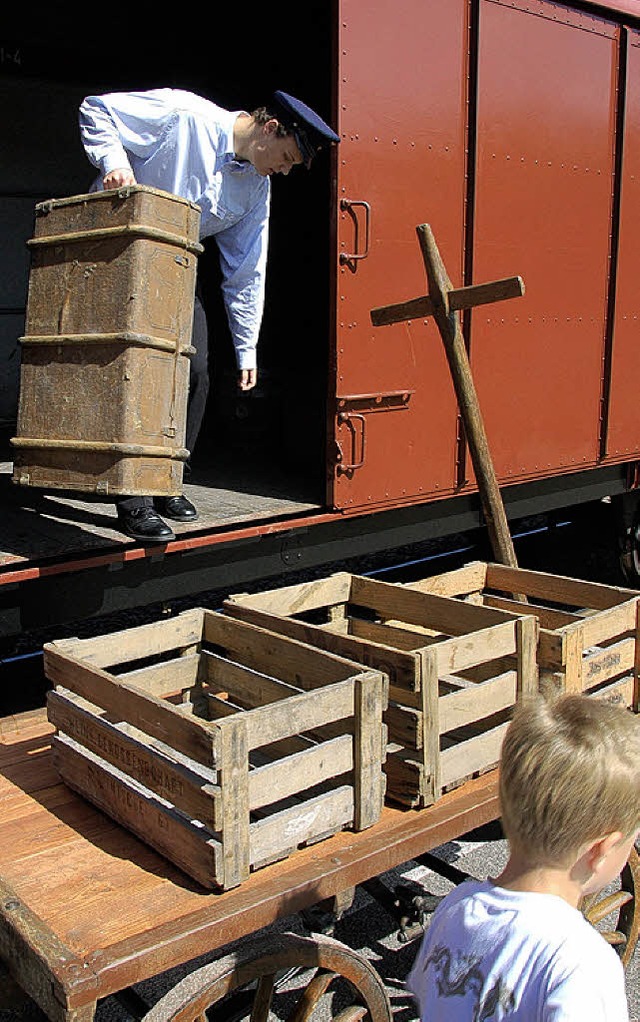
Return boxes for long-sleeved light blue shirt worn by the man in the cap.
[80,89,270,369]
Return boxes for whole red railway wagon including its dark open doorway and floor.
[0,0,640,654]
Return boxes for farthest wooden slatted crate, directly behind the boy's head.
[400,561,640,712]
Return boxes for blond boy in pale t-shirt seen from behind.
[407,696,640,1022]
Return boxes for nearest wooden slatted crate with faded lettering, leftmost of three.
[45,609,387,889]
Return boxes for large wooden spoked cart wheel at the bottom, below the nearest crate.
[142,933,392,1022]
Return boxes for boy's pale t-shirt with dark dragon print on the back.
[407,881,629,1022]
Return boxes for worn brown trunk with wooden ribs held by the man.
[12,186,201,496]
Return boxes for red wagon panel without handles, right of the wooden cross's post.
[471,0,620,482]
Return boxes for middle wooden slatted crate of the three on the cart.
[224,572,538,806]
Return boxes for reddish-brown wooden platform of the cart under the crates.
[0,710,498,1022]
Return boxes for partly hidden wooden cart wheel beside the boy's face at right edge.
[581,848,640,968]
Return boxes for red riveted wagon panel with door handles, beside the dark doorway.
[328,0,468,510]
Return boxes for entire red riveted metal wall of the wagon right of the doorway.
[332,0,640,508]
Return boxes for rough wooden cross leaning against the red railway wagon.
[371,224,524,567]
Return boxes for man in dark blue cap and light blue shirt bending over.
[80,89,339,543]
